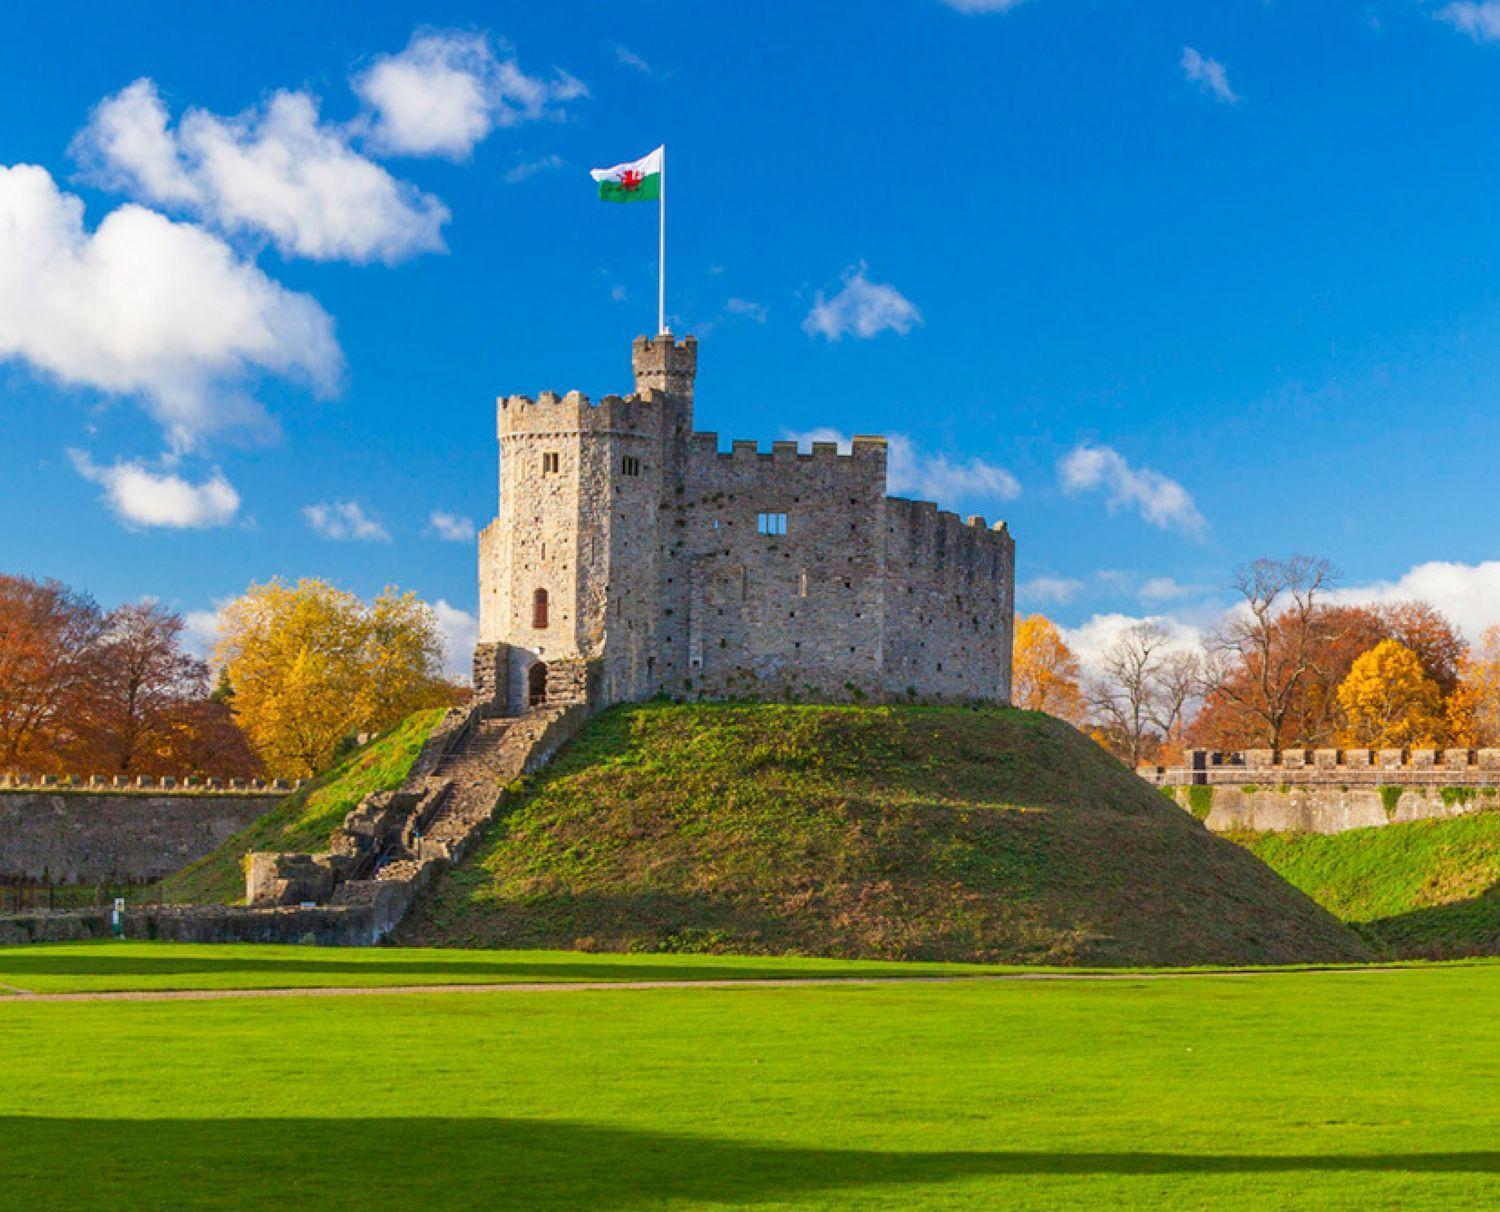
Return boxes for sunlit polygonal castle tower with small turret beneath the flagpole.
[476,335,698,711]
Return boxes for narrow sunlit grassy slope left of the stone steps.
[162,707,444,905]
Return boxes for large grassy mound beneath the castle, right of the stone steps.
[399,704,1368,965]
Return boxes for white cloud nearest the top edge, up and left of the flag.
[351,32,588,159]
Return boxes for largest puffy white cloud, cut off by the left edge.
[0,165,344,450]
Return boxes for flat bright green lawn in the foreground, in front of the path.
[0,947,1500,1209]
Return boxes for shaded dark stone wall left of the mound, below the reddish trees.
[0,788,285,884]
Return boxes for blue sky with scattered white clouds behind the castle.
[0,0,1500,672]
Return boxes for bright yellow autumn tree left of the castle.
[215,579,455,779]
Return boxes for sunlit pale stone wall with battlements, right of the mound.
[1137,749,1500,834]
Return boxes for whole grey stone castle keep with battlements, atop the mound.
[474,333,1016,714]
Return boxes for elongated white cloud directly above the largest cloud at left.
[74,80,450,264]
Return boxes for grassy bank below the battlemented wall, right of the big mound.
[1235,812,1500,959]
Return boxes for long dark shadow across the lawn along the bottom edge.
[0,1116,1500,1209]
